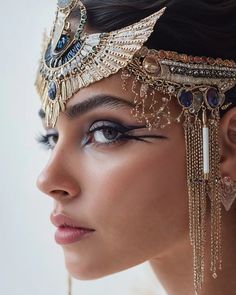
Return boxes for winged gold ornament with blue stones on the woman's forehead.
[36,0,165,127]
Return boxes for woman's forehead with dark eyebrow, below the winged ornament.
[39,71,180,130]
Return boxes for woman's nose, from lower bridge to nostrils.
[36,150,80,201]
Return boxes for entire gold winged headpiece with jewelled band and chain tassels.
[36,0,236,291]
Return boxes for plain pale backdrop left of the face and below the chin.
[0,0,165,295]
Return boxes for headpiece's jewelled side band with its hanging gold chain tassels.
[121,47,236,294]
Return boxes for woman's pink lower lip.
[55,227,94,245]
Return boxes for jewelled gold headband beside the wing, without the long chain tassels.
[121,46,236,128]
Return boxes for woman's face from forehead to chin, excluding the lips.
[37,74,188,280]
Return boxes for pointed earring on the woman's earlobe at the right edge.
[221,176,236,211]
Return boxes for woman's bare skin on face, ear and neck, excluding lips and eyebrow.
[37,73,236,295]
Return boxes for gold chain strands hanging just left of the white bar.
[184,111,206,293]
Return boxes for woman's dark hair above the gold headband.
[77,0,236,115]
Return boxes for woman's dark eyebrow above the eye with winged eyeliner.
[38,94,135,119]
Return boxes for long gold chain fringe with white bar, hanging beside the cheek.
[184,107,222,294]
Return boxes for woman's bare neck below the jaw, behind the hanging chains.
[149,209,236,295]
